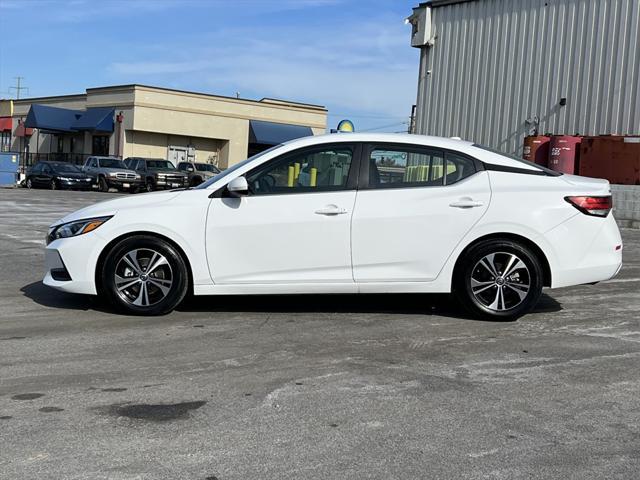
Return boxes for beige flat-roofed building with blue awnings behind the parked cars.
[0,85,327,168]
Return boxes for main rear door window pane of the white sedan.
[369,148,444,188]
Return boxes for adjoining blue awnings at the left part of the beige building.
[24,103,115,133]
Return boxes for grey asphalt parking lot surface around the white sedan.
[0,189,640,480]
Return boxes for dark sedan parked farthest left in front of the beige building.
[25,162,93,190]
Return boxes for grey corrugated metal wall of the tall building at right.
[416,0,640,154]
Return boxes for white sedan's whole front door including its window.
[207,144,357,285]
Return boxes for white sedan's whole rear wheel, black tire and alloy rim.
[454,239,543,320]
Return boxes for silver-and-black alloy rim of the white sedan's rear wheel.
[471,252,531,312]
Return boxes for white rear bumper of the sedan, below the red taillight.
[546,213,622,288]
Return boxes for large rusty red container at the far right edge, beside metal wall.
[580,135,640,185]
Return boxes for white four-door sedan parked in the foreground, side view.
[44,133,622,319]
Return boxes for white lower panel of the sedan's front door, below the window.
[207,190,356,284]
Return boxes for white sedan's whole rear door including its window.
[352,144,491,283]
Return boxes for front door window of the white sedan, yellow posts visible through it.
[247,146,353,195]
